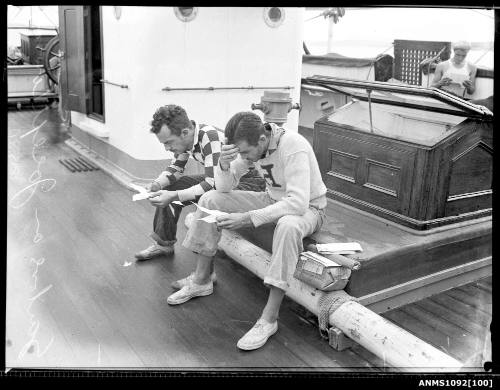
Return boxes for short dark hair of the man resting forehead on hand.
[224,111,266,146]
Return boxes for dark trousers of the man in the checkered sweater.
[151,169,266,246]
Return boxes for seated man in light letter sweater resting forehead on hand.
[167,112,326,350]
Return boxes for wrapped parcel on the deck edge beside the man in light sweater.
[293,251,351,291]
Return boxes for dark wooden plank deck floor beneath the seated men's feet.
[6,109,492,371]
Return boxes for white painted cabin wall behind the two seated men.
[71,6,304,160]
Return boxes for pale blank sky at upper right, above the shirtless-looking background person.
[304,7,495,68]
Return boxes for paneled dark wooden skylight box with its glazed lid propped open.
[306,76,493,230]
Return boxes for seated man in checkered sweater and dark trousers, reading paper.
[135,104,265,278]
